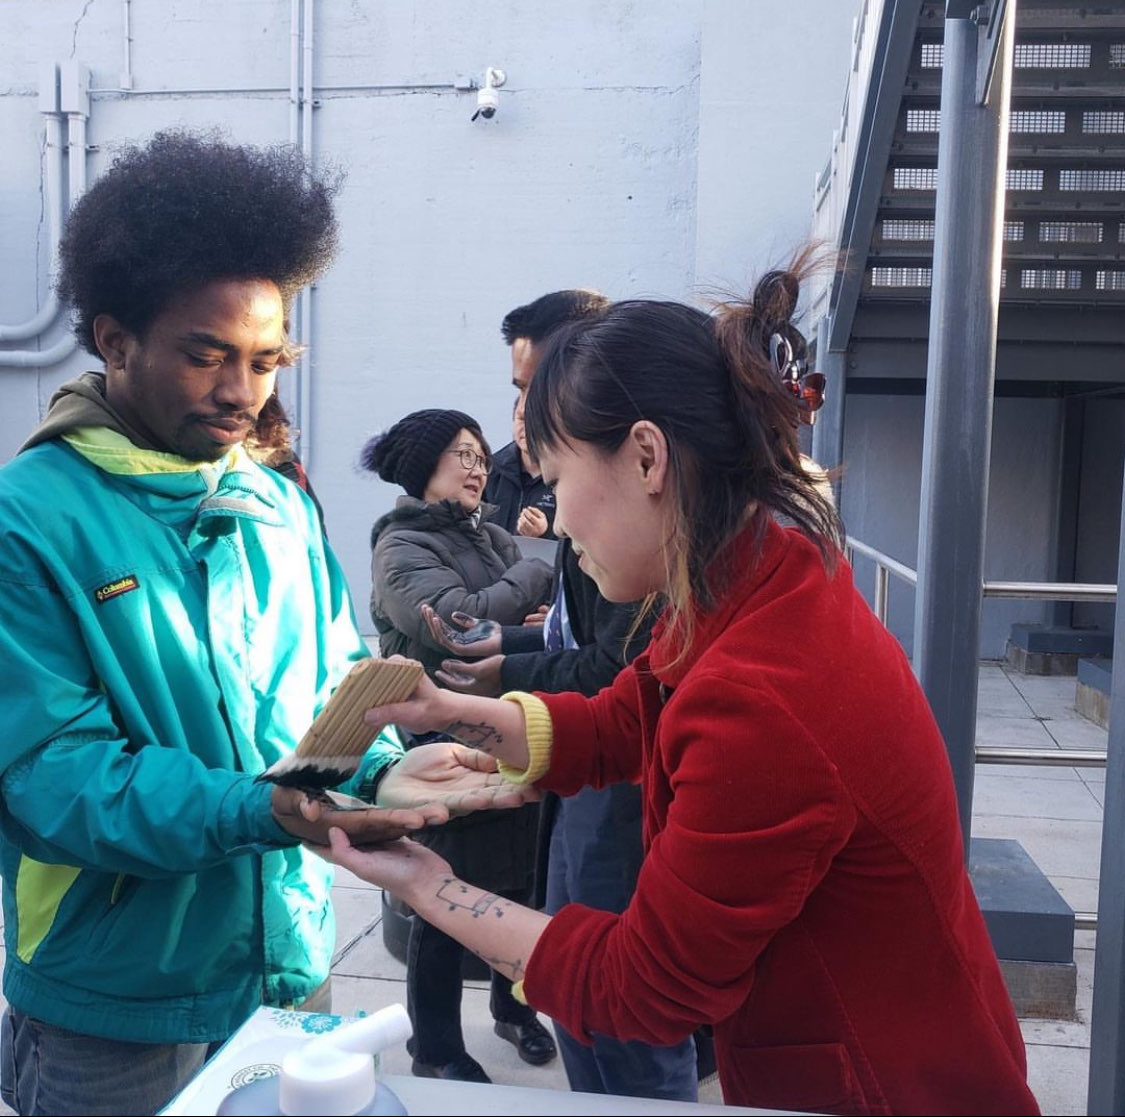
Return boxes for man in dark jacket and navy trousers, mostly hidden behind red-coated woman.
[430,290,698,1101]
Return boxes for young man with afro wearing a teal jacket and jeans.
[0,133,468,1114]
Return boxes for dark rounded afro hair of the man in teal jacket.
[57,132,339,357]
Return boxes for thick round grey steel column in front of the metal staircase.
[915,3,1016,841]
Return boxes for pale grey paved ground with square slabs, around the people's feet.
[0,663,1107,1115]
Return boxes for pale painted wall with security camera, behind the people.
[0,0,857,625]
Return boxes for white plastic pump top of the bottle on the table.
[278,1005,411,1117]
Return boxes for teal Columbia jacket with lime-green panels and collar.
[0,427,393,1043]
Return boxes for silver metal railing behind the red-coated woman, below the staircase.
[844,539,1117,930]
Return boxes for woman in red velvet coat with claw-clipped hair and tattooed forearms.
[321,259,1037,1114]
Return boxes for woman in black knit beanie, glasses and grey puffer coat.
[360,408,556,1082]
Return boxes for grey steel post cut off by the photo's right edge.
[1086,458,1125,1115]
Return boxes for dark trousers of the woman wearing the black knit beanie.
[406,897,534,1064]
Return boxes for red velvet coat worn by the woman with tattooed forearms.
[524,524,1038,1114]
